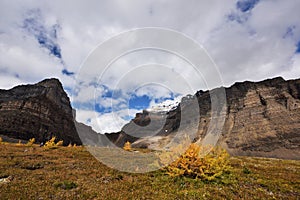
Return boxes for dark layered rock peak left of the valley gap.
[0,79,81,145]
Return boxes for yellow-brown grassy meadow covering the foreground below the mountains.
[0,143,300,199]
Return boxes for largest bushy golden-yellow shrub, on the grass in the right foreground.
[161,143,230,181]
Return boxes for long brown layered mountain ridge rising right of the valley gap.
[107,77,300,159]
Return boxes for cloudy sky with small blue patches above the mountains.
[0,0,300,133]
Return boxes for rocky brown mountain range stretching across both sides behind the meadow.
[0,77,300,159]
